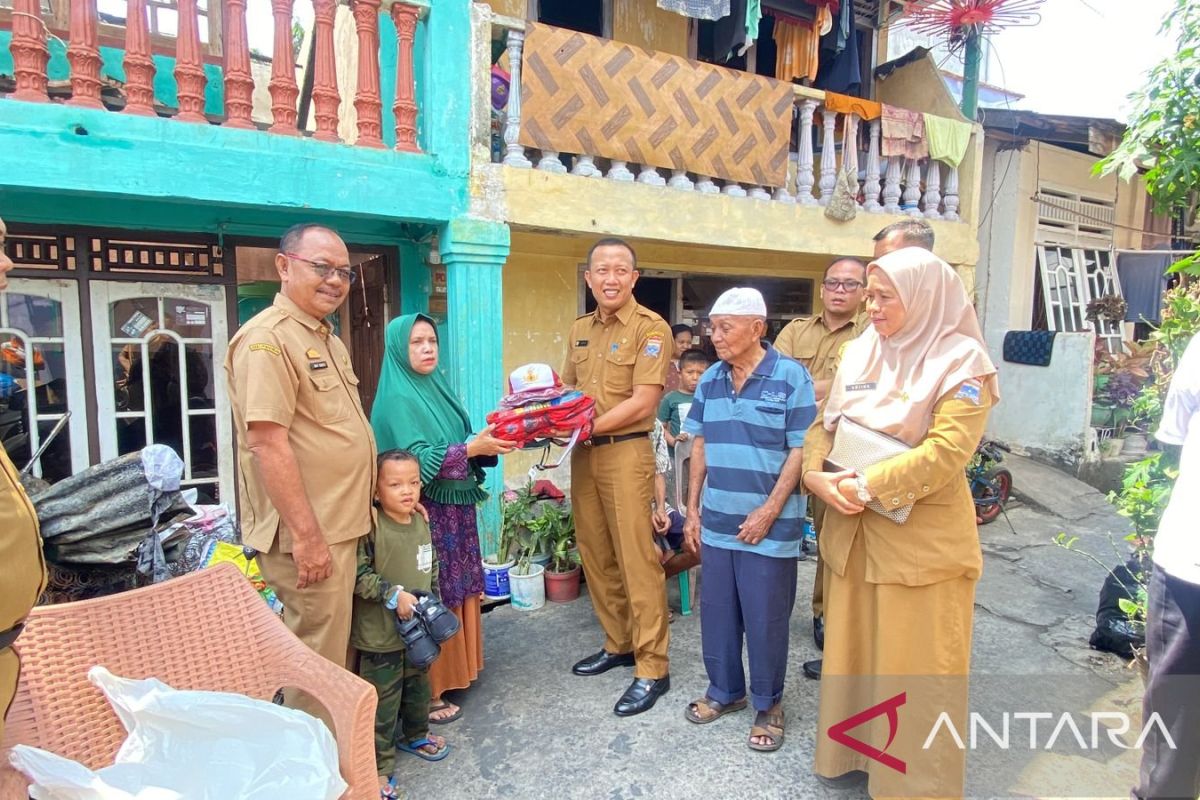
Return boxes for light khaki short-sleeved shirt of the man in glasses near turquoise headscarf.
[226,294,376,553]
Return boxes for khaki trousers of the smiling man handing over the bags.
[571,437,670,679]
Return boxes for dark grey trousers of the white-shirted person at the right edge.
[1133,565,1200,800]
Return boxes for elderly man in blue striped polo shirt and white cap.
[683,289,816,751]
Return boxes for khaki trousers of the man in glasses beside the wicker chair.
[258,536,359,724]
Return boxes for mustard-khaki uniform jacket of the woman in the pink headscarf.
[804,385,992,587]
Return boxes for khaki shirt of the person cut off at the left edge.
[0,447,46,638]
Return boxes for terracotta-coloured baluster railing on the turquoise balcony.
[0,0,428,152]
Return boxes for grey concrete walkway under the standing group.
[398,459,1141,800]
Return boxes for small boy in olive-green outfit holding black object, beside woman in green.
[350,450,449,800]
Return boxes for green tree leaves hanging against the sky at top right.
[1097,0,1200,219]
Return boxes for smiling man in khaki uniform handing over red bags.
[563,239,671,716]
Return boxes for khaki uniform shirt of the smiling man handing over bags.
[562,299,672,435]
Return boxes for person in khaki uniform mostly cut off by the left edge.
[0,219,46,739]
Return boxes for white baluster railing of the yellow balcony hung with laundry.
[491,14,979,222]
